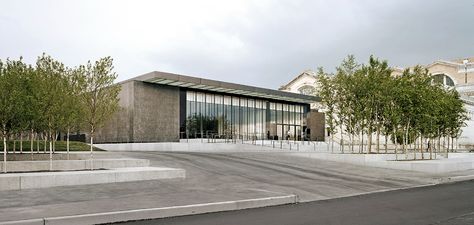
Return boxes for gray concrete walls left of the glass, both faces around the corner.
[94,81,179,143]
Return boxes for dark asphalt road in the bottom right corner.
[117,181,474,225]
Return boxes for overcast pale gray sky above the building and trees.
[0,0,474,88]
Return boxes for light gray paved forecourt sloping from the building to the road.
[0,152,472,221]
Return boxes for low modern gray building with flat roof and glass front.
[95,72,324,143]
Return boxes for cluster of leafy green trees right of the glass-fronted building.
[318,55,468,159]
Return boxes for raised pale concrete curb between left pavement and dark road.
[0,195,298,225]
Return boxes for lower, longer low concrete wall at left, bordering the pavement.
[0,167,186,190]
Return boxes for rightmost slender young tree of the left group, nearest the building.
[80,57,120,170]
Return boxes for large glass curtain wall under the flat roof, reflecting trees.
[185,91,308,140]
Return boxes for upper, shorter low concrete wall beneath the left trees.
[0,159,150,172]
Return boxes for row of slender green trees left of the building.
[0,54,120,172]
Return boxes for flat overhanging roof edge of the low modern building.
[128,71,321,104]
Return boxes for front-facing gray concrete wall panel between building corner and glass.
[133,82,179,142]
